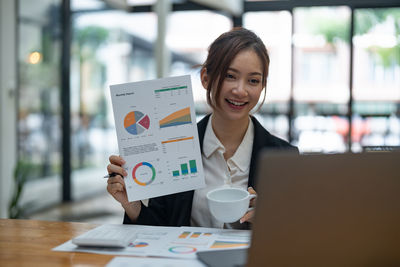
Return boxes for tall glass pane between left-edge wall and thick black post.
[18,0,61,209]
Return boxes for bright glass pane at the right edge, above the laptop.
[352,8,400,150]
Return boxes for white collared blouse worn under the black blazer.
[190,115,254,229]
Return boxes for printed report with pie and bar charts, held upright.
[110,75,205,201]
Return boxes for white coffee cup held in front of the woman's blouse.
[207,187,256,223]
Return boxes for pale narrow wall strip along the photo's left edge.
[0,0,17,218]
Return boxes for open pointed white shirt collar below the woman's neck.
[203,115,254,172]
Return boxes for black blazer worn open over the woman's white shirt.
[124,115,298,226]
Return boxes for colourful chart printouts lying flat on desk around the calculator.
[53,225,251,259]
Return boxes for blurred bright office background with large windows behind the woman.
[0,0,400,223]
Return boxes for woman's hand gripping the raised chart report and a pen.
[107,155,129,206]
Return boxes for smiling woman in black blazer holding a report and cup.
[107,28,298,229]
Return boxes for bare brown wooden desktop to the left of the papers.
[0,219,114,266]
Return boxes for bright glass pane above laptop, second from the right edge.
[293,7,351,152]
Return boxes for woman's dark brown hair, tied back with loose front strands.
[202,27,269,110]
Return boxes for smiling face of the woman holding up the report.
[202,49,263,124]
